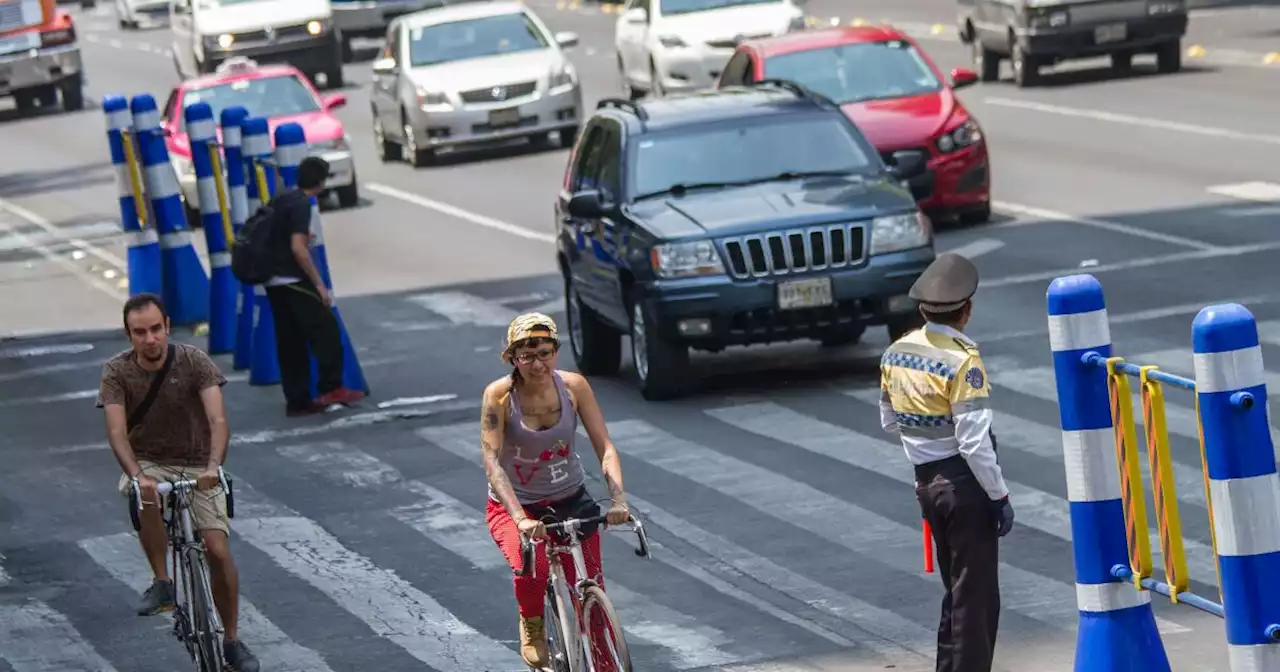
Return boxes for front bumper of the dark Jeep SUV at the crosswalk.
[640,246,934,349]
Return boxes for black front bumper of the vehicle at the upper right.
[1018,14,1187,59]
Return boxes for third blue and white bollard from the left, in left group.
[183,101,239,355]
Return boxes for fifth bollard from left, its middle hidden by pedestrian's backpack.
[241,116,280,385]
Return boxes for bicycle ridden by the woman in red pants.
[520,501,653,672]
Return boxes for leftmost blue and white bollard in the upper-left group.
[102,96,164,296]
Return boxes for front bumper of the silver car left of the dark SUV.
[410,82,582,148]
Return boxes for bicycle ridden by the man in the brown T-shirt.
[129,467,236,672]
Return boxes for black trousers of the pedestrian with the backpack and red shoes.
[266,280,342,408]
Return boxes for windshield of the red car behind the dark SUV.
[764,40,942,105]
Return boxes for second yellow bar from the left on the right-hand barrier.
[1138,366,1189,604]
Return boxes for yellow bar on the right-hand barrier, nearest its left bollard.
[1107,357,1153,581]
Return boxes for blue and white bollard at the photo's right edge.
[1192,303,1280,672]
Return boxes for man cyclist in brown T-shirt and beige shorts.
[97,293,259,672]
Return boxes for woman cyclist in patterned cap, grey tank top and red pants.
[480,312,630,669]
